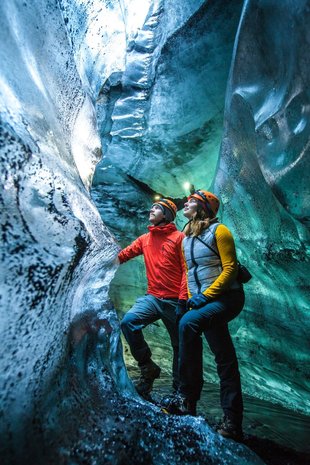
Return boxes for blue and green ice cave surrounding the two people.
[0,0,310,465]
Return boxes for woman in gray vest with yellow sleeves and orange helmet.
[171,190,244,440]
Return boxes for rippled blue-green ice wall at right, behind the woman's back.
[214,1,310,412]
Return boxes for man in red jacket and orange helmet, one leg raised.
[118,199,187,395]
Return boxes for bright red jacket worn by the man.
[118,223,187,299]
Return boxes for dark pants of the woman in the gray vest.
[179,290,244,425]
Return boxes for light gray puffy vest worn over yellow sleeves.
[183,223,240,295]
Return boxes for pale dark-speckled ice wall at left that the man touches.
[0,0,261,465]
